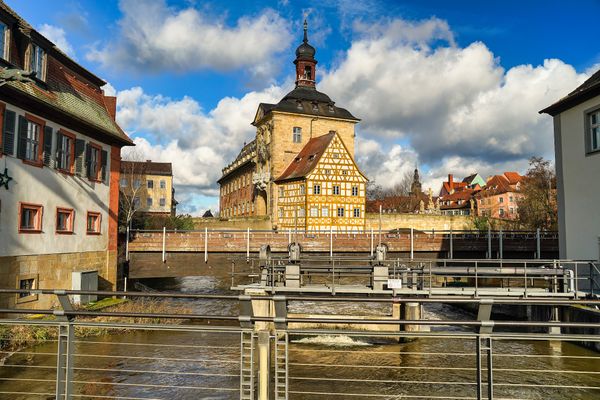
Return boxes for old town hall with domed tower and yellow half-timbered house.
[219,22,367,232]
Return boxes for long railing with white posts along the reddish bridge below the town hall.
[125,228,558,262]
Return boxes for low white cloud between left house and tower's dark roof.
[117,86,284,209]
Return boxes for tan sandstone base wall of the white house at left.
[0,250,117,309]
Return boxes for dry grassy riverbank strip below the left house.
[0,298,191,353]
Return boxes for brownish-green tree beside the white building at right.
[517,157,558,230]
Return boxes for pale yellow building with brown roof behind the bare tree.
[120,160,177,216]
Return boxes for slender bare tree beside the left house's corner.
[119,149,146,231]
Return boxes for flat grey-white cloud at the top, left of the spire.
[87,0,291,82]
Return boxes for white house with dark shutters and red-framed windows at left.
[0,2,132,308]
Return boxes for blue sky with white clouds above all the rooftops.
[6,0,600,214]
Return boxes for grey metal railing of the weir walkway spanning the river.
[230,255,600,298]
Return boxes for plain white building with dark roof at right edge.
[540,67,600,260]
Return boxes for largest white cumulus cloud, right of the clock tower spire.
[319,18,588,191]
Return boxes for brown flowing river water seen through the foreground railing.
[0,256,600,400]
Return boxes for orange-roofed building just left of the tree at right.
[475,172,523,220]
